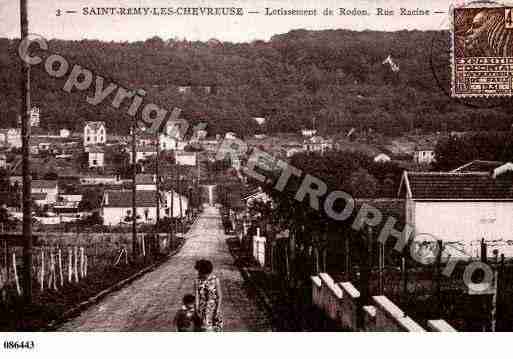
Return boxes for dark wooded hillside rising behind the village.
[0,30,511,137]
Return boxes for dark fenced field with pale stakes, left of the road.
[0,233,184,331]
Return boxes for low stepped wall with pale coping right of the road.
[311,273,456,332]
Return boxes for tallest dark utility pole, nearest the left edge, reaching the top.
[20,0,32,304]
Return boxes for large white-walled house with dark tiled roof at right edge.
[399,169,513,252]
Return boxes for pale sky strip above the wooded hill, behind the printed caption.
[0,0,450,42]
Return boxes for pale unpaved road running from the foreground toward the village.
[60,207,271,331]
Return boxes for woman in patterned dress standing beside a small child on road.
[194,259,223,332]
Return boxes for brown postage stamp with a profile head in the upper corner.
[451,2,513,97]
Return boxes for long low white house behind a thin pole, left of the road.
[100,190,165,226]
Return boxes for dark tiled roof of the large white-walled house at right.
[401,172,513,200]
